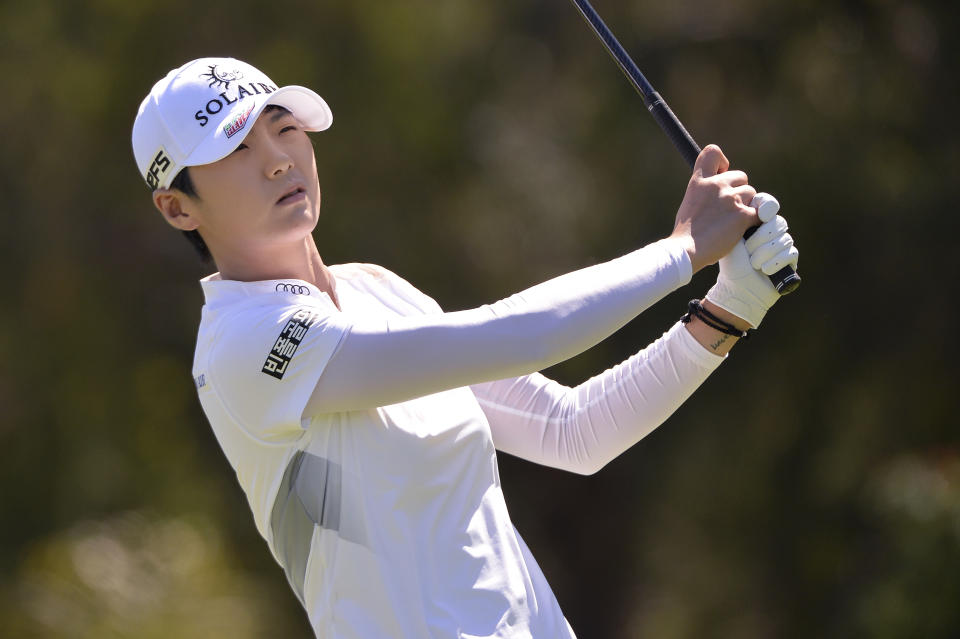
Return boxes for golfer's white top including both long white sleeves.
[194,241,722,638]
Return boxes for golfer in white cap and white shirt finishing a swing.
[133,58,797,639]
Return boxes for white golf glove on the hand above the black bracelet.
[707,193,800,328]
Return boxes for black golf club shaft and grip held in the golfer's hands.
[572,0,800,295]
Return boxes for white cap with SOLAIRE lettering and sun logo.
[132,58,333,190]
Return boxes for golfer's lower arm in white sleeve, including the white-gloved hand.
[472,162,799,474]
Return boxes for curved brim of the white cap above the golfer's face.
[180,85,333,174]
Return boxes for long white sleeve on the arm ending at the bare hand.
[308,241,691,412]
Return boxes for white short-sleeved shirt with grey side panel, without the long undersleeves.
[194,264,574,639]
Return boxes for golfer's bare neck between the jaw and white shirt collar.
[214,235,340,308]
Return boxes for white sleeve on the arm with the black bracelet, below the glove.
[474,323,723,474]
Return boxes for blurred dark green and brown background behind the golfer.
[0,0,960,639]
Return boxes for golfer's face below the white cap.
[169,107,320,256]
